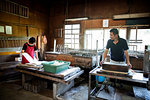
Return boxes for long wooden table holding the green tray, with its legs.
[16,64,84,100]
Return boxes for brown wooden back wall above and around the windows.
[49,0,150,50]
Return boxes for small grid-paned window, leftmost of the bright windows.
[64,24,80,49]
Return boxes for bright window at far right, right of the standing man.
[129,29,150,52]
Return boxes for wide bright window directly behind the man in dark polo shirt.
[84,29,126,50]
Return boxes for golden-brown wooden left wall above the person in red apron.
[0,0,49,37]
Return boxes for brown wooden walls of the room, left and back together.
[0,0,150,50]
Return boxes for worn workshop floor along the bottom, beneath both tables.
[0,82,149,100]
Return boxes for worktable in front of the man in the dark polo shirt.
[88,67,148,100]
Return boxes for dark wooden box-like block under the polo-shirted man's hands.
[97,62,131,77]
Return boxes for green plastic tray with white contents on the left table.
[42,60,70,73]
